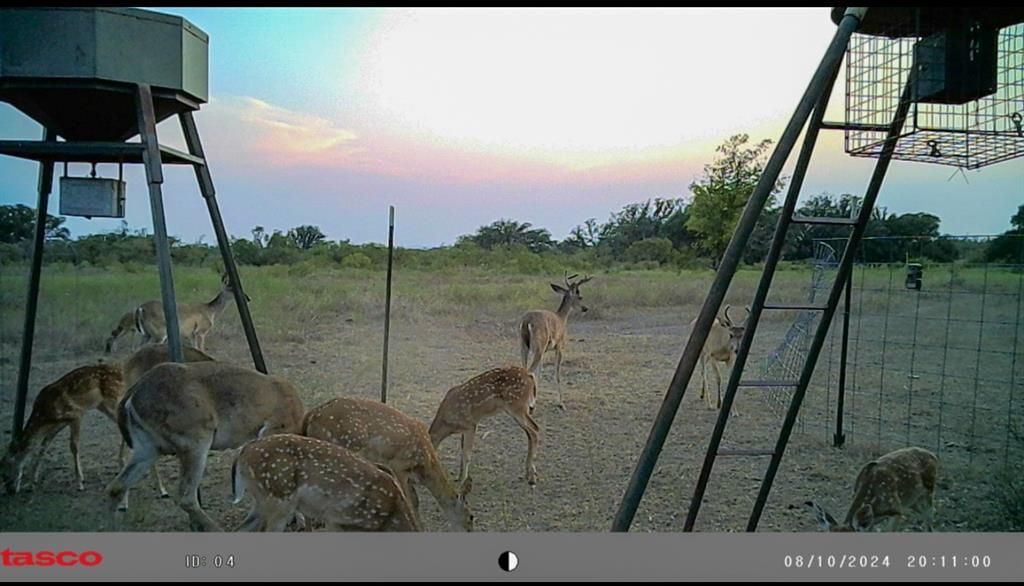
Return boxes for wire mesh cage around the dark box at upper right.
[846,24,1024,169]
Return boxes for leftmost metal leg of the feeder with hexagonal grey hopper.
[10,128,57,443]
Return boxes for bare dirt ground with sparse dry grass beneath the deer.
[0,282,1007,532]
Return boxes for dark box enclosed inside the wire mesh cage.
[913,26,999,104]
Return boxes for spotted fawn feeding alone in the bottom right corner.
[804,447,939,532]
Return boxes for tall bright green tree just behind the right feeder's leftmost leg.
[686,134,785,267]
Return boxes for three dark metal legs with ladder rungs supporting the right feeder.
[612,9,912,532]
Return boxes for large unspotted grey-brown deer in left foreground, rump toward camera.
[106,362,303,531]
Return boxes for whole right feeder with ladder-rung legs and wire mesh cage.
[611,5,1024,531]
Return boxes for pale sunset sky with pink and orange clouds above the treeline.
[0,8,1024,247]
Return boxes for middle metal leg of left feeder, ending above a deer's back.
[135,83,185,363]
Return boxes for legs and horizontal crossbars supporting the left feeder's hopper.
[8,84,267,441]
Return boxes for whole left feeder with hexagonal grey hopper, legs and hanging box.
[0,8,266,437]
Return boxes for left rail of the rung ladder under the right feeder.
[683,34,841,531]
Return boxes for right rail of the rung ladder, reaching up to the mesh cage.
[746,68,915,531]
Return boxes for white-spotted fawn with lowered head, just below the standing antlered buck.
[429,367,541,486]
